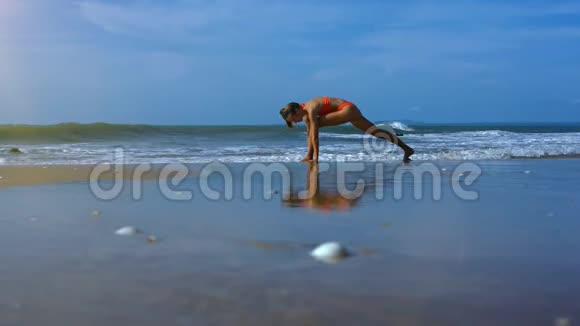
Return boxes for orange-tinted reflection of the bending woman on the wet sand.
[283,162,359,211]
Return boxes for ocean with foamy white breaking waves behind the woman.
[0,121,580,165]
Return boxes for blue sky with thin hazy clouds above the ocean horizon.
[0,0,580,124]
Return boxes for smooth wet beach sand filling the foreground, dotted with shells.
[0,159,580,326]
